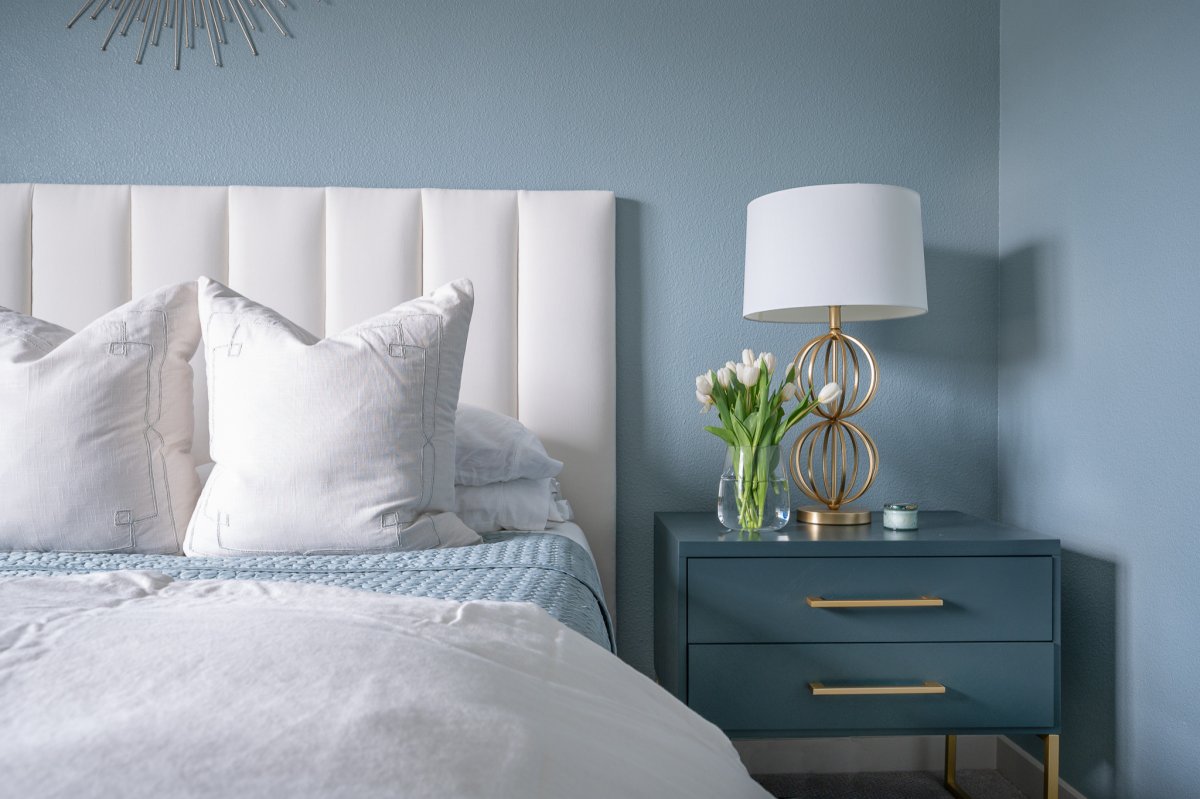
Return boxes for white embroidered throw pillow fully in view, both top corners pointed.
[184,278,480,555]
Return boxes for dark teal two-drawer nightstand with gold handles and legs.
[654,511,1061,799]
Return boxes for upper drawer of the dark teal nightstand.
[688,557,1054,643]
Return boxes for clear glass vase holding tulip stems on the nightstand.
[716,446,792,533]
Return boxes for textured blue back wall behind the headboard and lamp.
[0,0,998,669]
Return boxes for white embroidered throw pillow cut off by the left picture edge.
[0,282,200,553]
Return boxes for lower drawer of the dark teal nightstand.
[688,643,1056,735]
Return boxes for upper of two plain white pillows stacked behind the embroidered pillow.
[455,404,563,486]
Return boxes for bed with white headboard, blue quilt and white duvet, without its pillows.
[0,185,766,797]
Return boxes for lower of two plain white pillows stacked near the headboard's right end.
[455,477,571,533]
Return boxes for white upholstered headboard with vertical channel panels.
[0,184,617,607]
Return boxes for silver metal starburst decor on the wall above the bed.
[67,0,319,70]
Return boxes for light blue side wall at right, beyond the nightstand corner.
[1000,0,1200,799]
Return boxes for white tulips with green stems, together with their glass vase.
[696,349,841,531]
